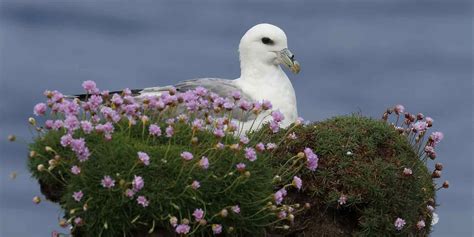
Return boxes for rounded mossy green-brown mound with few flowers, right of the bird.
[272,115,435,236]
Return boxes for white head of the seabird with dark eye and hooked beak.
[239,23,300,73]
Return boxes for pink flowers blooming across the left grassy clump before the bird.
[33,81,312,235]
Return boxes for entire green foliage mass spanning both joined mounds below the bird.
[28,115,435,236]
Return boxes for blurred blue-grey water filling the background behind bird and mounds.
[0,0,474,236]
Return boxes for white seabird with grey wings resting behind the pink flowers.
[137,24,300,130]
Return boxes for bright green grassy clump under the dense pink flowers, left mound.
[29,123,276,236]
